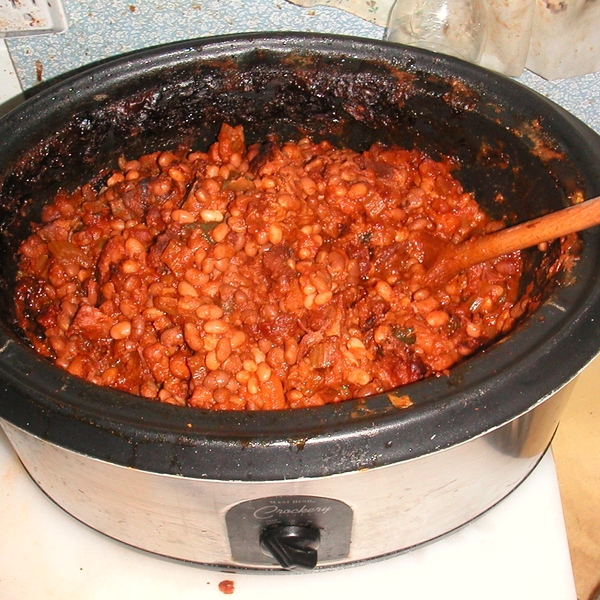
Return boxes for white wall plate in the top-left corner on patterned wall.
[0,0,67,38]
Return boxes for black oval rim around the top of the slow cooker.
[0,33,600,480]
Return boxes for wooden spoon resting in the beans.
[423,196,600,287]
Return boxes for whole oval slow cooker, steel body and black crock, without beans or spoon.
[0,34,600,570]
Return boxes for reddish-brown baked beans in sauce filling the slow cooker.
[15,125,523,410]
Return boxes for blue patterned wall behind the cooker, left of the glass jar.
[7,0,383,89]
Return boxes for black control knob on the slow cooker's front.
[260,525,320,571]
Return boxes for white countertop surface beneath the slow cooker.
[0,424,576,600]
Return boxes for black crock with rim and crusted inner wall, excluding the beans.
[0,34,600,481]
